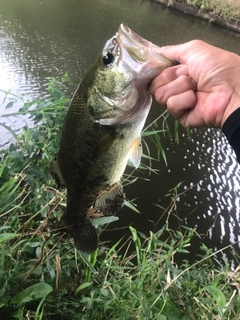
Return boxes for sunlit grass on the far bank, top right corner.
[152,0,240,33]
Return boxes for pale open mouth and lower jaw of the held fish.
[97,24,176,125]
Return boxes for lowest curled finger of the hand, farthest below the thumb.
[167,90,197,127]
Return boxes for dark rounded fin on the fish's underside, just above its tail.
[95,182,124,216]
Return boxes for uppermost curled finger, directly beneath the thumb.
[149,65,188,95]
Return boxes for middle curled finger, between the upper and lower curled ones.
[155,75,196,104]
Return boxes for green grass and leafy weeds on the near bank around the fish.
[0,82,240,320]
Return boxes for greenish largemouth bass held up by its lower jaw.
[51,24,175,254]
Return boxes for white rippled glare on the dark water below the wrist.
[177,129,240,250]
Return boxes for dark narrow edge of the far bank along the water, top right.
[152,0,240,33]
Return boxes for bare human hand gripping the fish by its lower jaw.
[149,40,240,128]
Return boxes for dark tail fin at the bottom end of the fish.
[61,213,98,254]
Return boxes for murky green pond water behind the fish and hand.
[0,0,240,260]
